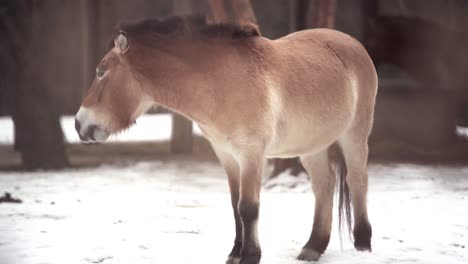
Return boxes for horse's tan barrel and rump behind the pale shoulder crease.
[268,29,377,157]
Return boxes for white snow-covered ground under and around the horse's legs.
[0,161,468,264]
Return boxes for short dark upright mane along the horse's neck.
[117,15,260,39]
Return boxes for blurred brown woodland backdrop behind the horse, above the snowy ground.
[0,0,468,170]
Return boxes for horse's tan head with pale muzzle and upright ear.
[75,33,152,142]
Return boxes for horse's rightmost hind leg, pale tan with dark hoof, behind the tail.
[339,133,372,251]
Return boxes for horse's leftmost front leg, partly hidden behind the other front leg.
[214,147,242,264]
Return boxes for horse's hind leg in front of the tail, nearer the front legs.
[297,150,336,261]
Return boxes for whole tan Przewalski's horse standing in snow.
[76,16,377,264]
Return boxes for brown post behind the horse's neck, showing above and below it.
[171,0,194,154]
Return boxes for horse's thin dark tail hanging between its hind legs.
[329,142,352,240]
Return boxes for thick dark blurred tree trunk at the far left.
[1,0,68,169]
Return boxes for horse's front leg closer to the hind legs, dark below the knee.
[237,154,264,264]
